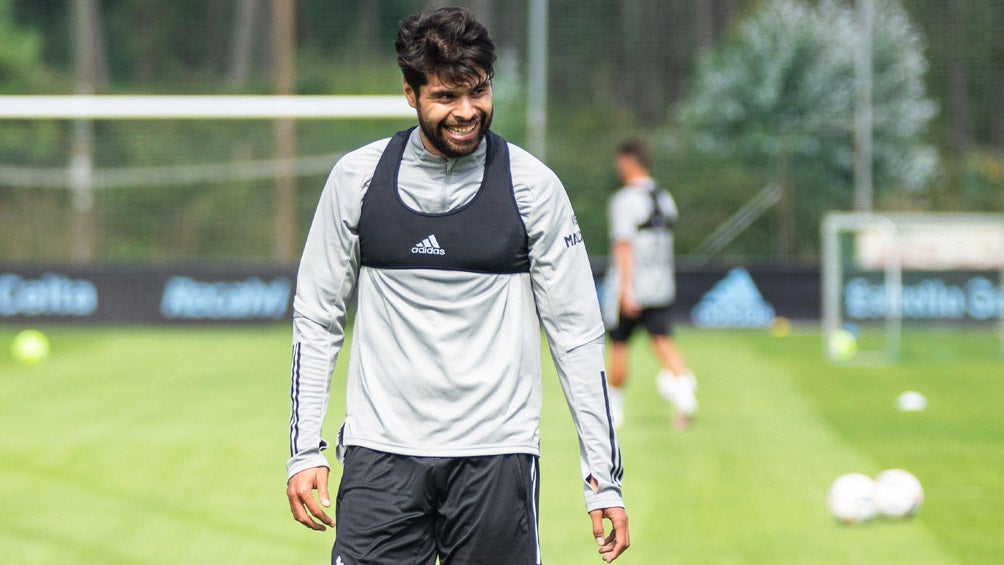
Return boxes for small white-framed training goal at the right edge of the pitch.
[821,213,1004,364]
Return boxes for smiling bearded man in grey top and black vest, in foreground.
[286,8,630,565]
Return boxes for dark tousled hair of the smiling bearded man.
[394,8,495,92]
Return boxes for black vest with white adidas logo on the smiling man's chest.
[358,127,530,274]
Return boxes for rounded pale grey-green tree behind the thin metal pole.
[680,0,937,256]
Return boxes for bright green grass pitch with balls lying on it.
[0,325,1004,565]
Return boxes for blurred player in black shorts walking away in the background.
[604,139,697,429]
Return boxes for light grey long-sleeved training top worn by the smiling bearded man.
[287,129,623,510]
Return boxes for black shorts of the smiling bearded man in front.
[331,447,540,565]
